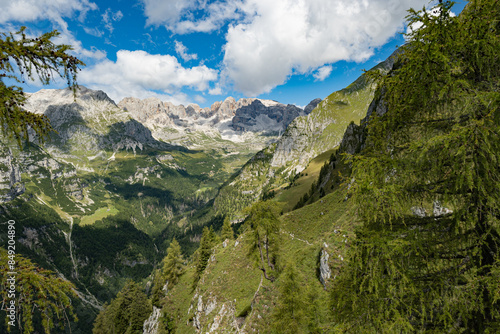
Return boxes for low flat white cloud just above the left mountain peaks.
[79,50,218,103]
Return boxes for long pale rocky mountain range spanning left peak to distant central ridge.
[21,86,320,151]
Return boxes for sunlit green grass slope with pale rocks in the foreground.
[158,188,356,333]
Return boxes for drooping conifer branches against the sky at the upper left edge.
[0,27,85,145]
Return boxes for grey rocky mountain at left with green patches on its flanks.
[26,87,171,153]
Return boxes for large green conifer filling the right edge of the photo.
[332,0,500,333]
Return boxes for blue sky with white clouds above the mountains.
[0,0,466,107]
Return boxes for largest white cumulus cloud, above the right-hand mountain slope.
[223,0,428,95]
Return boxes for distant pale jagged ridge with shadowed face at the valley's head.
[114,93,321,149]
